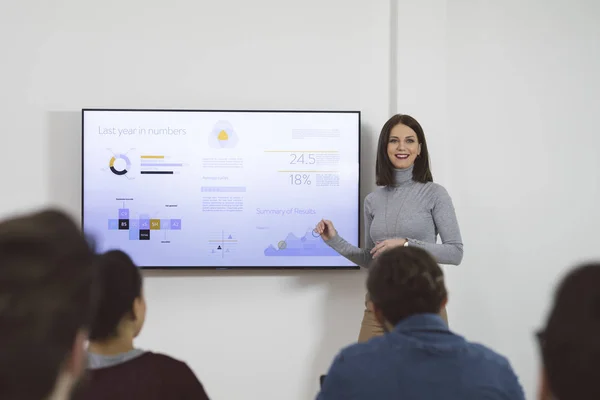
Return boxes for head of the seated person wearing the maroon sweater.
[90,250,146,343]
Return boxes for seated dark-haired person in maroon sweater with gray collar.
[75,250,208,400]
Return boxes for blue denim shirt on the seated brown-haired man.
[317,314,525,400]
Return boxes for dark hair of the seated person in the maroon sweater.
[90,250,142,341]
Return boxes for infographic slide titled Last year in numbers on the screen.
[82,109,360,268]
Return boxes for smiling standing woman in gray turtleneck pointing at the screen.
[315,114,463,342]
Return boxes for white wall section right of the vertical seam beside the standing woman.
[396,0,600,398]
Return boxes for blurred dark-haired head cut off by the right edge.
[538,263,600,400]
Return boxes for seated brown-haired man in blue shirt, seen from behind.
[317,247,525,400]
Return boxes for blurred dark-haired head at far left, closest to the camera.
[0,211,94,400]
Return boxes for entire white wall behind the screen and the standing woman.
[0,0,600,400]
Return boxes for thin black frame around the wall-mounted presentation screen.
[81,108,360,271]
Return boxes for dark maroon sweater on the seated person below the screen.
[72,352,208,400]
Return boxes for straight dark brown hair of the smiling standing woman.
[375,114,433,186]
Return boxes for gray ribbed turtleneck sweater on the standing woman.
[326,167,463,268]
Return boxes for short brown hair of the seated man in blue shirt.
[367,247,448,325]
